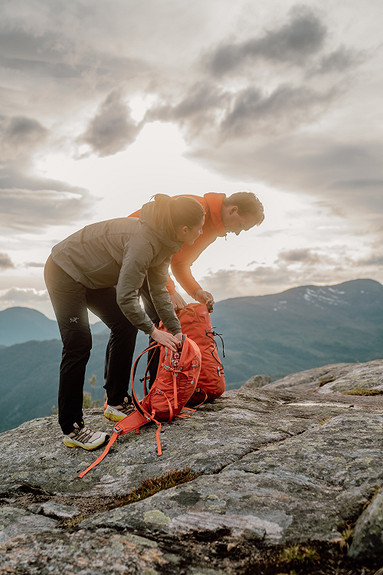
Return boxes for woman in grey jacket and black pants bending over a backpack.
[44,194,204,450]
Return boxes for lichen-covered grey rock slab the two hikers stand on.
[0,360,383,575]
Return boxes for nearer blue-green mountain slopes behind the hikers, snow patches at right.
[0,280,383,431]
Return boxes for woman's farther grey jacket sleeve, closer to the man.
[147,257,182,335]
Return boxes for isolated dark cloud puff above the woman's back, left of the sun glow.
[79,91,140,156]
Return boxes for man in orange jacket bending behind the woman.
[131,192,264,321]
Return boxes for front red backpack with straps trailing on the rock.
[79,335,201,477]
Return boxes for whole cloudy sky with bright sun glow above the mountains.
[0,0,383,317]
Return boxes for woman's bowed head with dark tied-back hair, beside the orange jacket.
[154,194,205,238]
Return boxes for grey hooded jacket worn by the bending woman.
[51,202,182,334]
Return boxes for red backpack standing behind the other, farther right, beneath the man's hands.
[164,303,225,406]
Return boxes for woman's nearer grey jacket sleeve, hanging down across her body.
[116,235,159,334]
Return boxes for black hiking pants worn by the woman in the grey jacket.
[44,257,137,435]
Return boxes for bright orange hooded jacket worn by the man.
[130,192,226,298]
